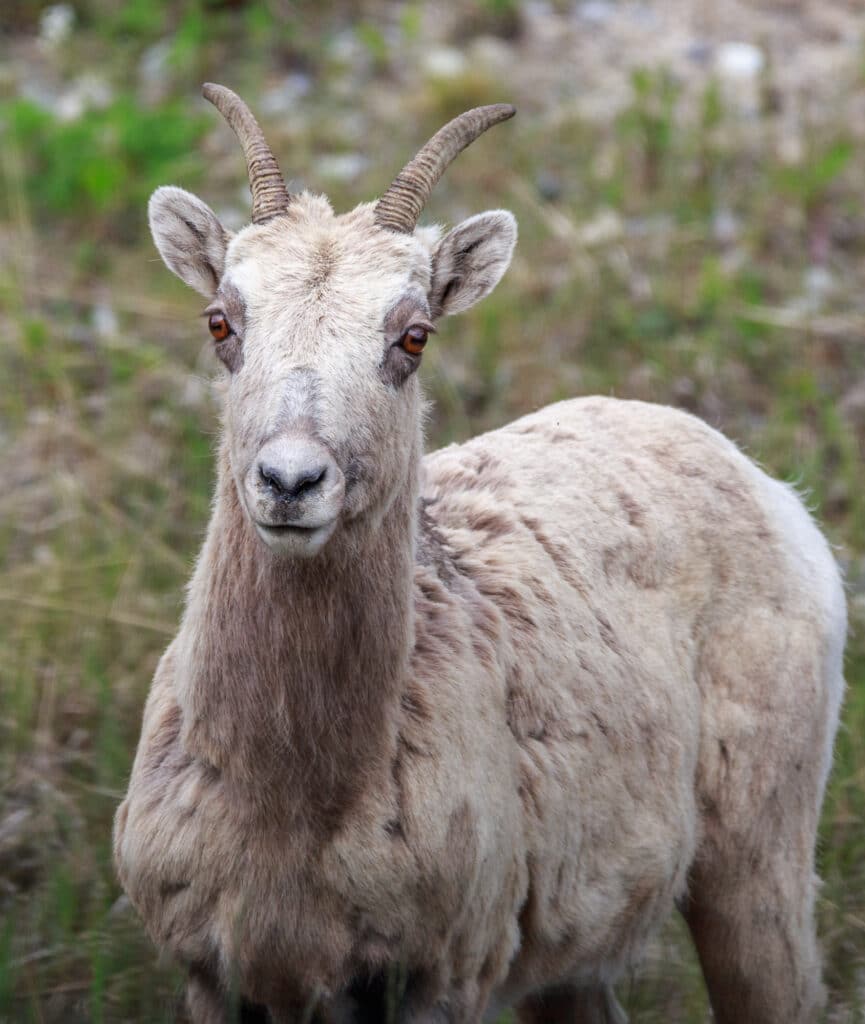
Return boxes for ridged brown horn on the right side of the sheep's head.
[376,103,517,234]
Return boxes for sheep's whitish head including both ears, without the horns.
[149,187,516,557]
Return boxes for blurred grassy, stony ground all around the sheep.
[0,0,865,1024]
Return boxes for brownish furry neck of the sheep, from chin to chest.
[176,443,420,820]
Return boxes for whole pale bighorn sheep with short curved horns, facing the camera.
[116,85,846,1024]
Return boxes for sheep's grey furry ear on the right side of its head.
[429,210,517,316]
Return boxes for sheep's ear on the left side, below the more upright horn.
[147,185,230,299]
